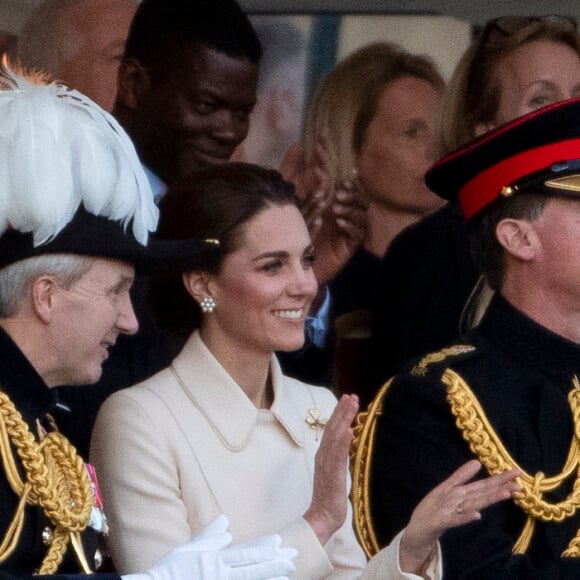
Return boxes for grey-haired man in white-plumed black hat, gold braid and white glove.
[0,69,295,580]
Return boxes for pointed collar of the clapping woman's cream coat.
[170,332,316,450]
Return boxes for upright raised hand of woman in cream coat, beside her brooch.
[304,395,358,546]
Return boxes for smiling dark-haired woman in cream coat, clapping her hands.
[91,164,515,579]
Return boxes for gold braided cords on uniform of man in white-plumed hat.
[0,391,94,574]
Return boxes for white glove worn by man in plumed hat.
[121,515,297,580]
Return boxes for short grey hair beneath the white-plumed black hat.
[0,254,95,318]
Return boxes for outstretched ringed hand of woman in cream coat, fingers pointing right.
[399,460,520,574]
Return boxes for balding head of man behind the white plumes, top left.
[18,0,137,111]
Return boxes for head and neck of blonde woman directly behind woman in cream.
[286,43,444,256]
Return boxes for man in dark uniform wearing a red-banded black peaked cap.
[354,100,580,580]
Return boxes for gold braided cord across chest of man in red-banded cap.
[441,369,580,557]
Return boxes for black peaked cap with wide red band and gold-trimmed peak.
[425,98,580,220]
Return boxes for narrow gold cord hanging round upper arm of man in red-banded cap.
[350,379,393,558]
